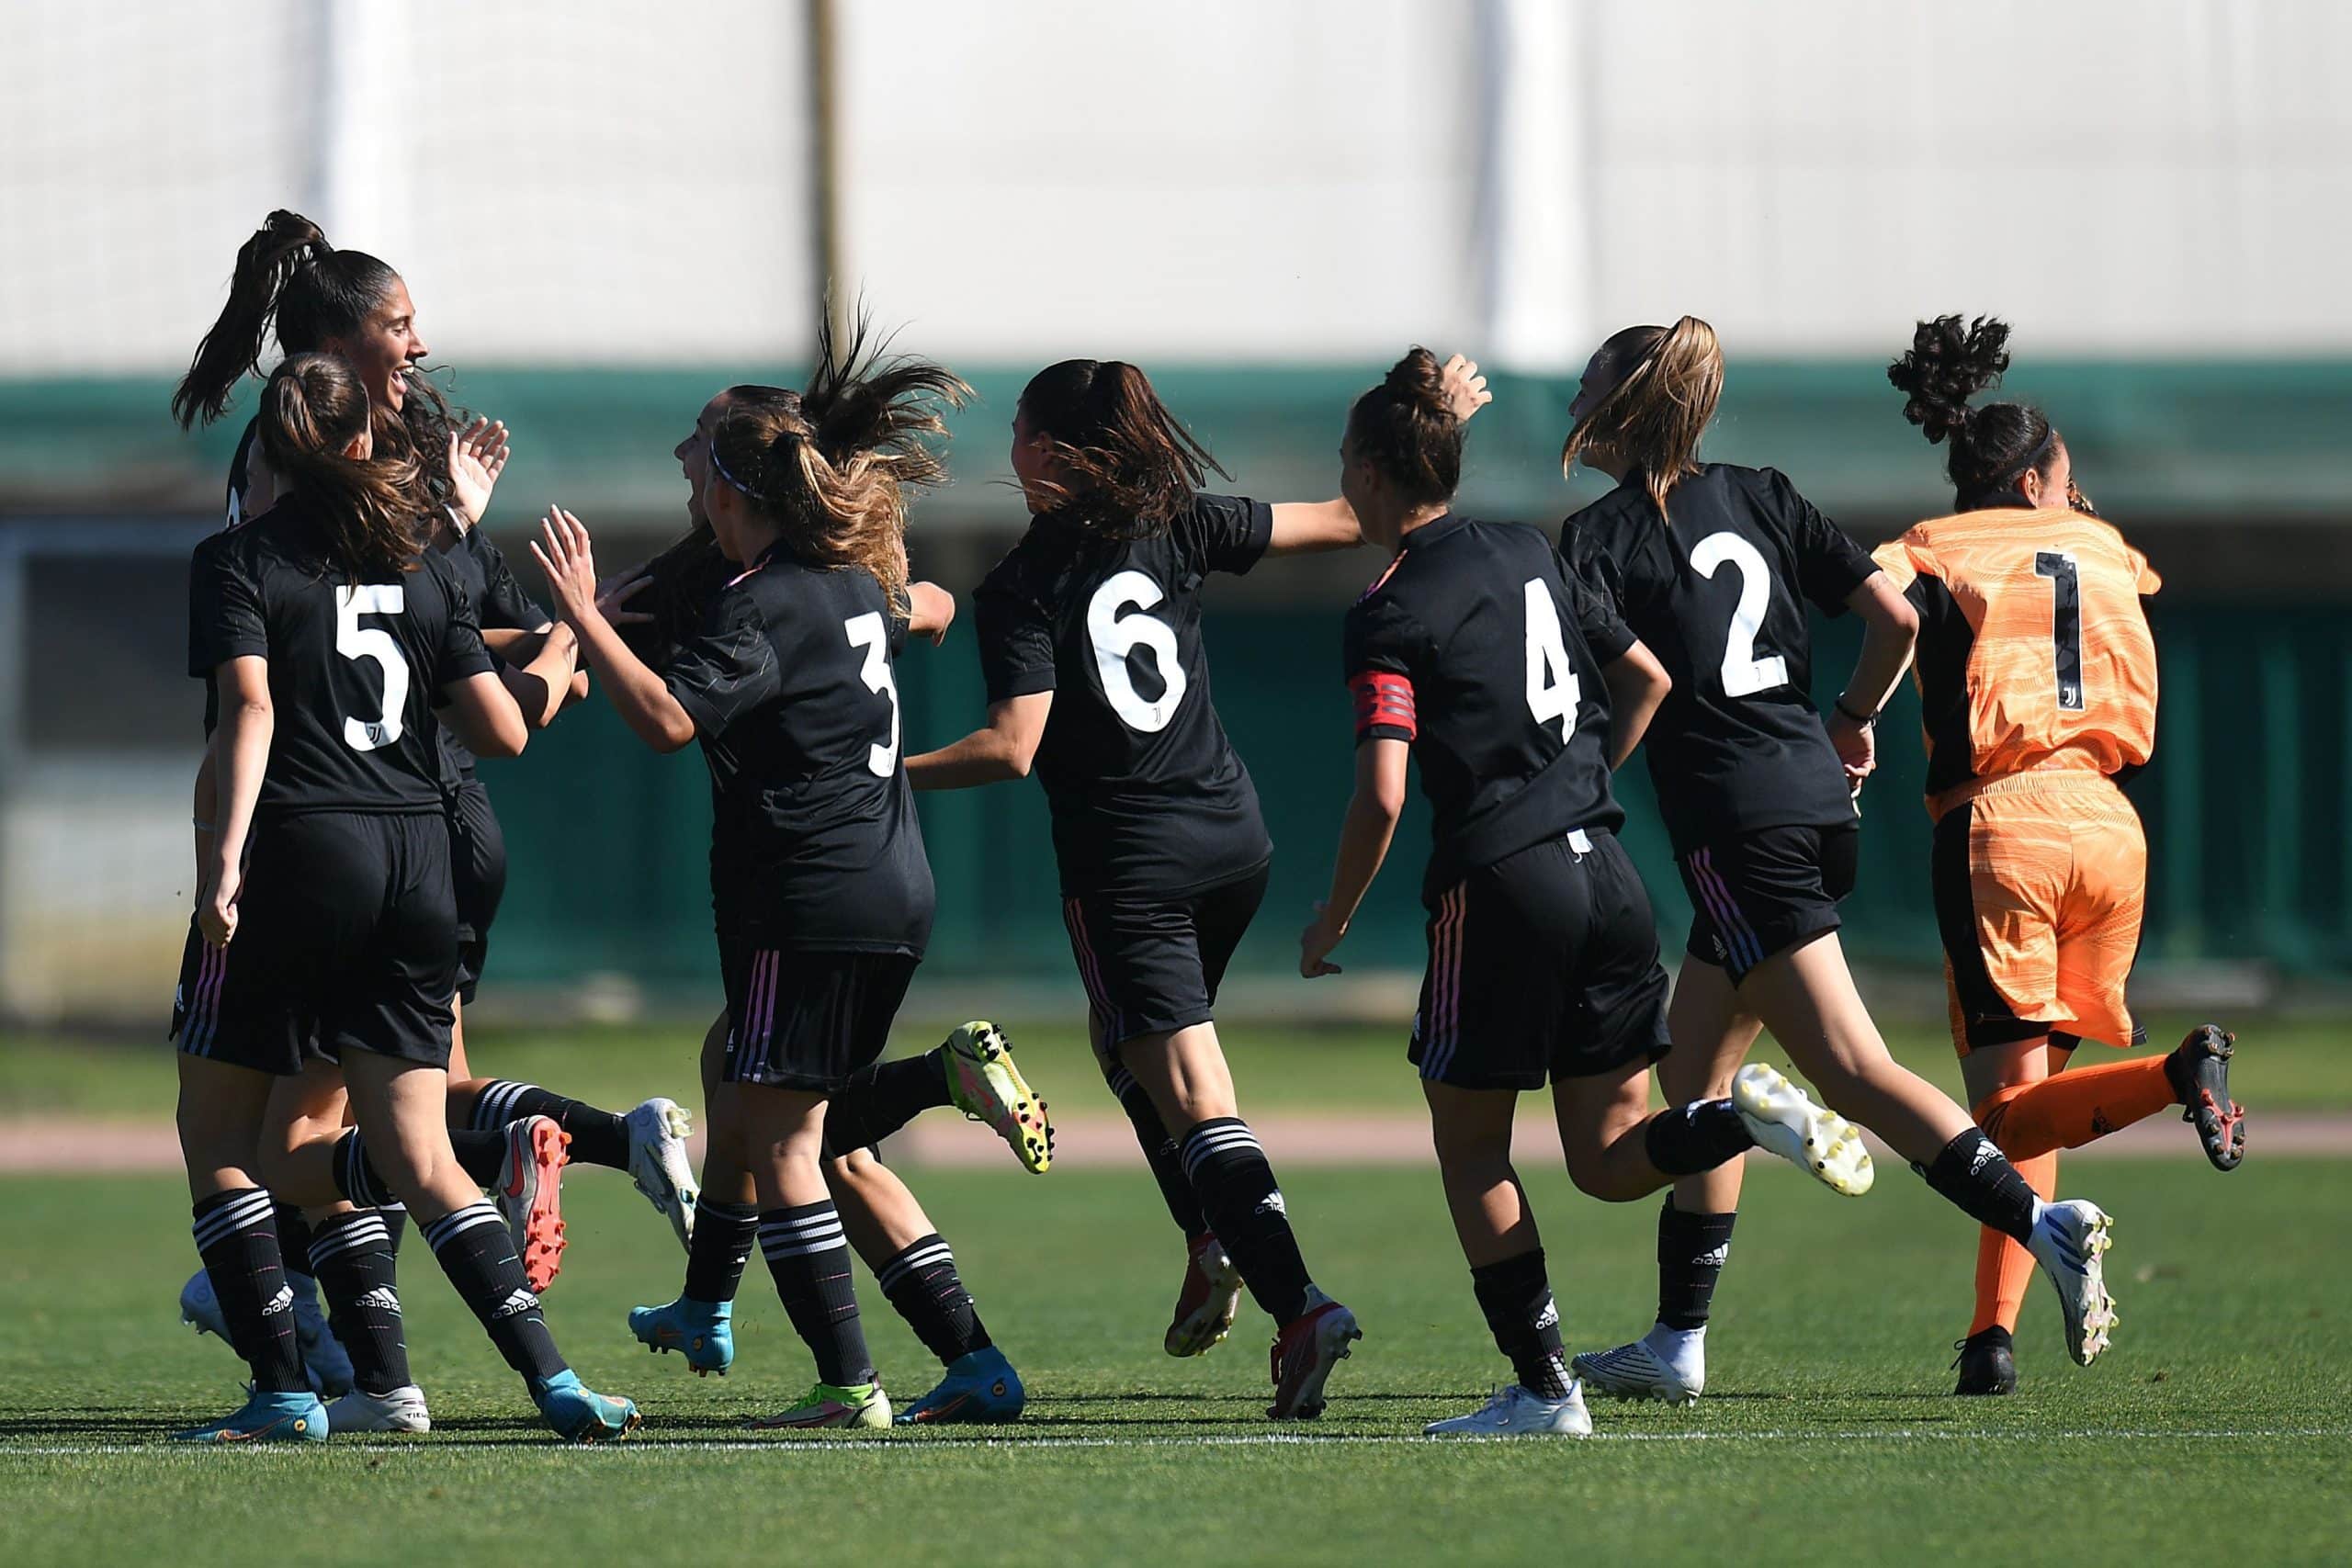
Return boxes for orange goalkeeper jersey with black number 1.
[1872,508,2162,804]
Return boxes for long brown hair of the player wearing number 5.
[259,355,424,583]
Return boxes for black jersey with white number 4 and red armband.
[1345,517,1634,908]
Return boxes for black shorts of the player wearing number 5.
[172,811,457,1075]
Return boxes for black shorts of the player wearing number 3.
[719,936,922,1093]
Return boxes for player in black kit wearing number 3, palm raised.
[532,333,983,1427]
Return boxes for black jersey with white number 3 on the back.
[663,550,936,954]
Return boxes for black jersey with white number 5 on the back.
[188,496,492,813]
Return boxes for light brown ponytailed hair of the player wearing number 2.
[1559,315,1724,517]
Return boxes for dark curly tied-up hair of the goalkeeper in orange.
[1886,315,2058,513]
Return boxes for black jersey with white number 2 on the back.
[1562,463,1877,853]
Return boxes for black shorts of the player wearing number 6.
[1061,865,1268,1048]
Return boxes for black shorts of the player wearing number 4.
[1407,832,1668,1089]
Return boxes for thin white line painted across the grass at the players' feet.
[0,1427,2352,1458]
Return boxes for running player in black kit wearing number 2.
[1562,315,2114,1401]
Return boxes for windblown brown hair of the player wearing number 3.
[710,317,971,616]
